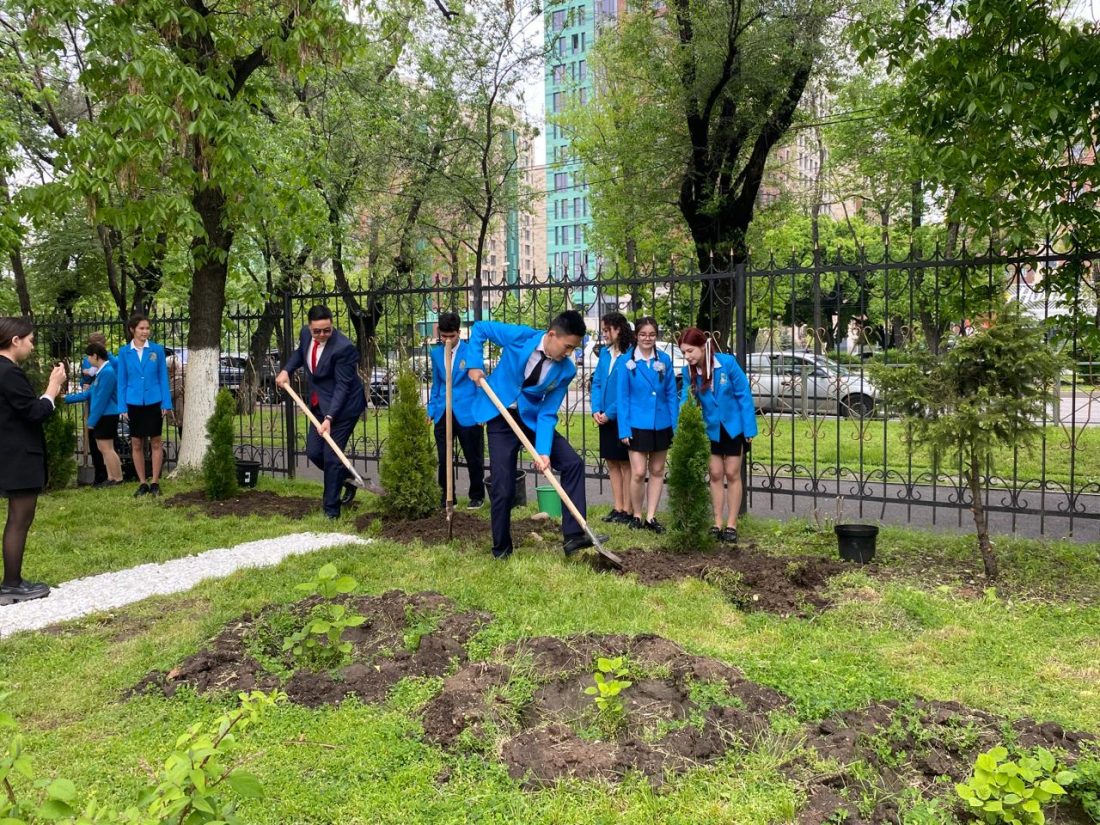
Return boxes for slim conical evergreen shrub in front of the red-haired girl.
[668,398,714,552]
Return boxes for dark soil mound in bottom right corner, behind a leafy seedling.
[793,700,1095,825]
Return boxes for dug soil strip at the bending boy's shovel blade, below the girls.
[592,545,851,616]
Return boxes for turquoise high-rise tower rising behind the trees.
[543,0,626,279]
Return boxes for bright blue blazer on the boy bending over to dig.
[466,321,576,455]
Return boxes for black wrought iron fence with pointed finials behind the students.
[40,244,1100,543]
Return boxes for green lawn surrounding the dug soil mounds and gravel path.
[0,481,1100,824]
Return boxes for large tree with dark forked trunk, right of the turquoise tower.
[572,0,835,340]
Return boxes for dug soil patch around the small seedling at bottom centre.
[424,635,787,788]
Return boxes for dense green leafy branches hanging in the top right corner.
[859,0,1100,351]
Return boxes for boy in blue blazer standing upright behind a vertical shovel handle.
[428,312,485,510]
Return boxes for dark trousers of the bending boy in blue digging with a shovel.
[488,410,589,558]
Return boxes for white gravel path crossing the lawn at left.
[0,532,371,638]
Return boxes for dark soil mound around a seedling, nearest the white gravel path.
[133,591,491,707]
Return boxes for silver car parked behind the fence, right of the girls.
[748,351,878,418]
